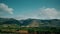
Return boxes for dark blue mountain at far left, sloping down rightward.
[0,18,21,25]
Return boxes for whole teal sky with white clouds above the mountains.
[0,0,60,20]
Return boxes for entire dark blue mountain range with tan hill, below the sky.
[0,18,60,27]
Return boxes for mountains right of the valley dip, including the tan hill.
[20,19,60,27]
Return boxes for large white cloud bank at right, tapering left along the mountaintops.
[15,7,60,19]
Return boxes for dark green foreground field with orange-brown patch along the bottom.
[0,26,60,34]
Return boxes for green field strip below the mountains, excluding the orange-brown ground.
[0,25,60,34]
